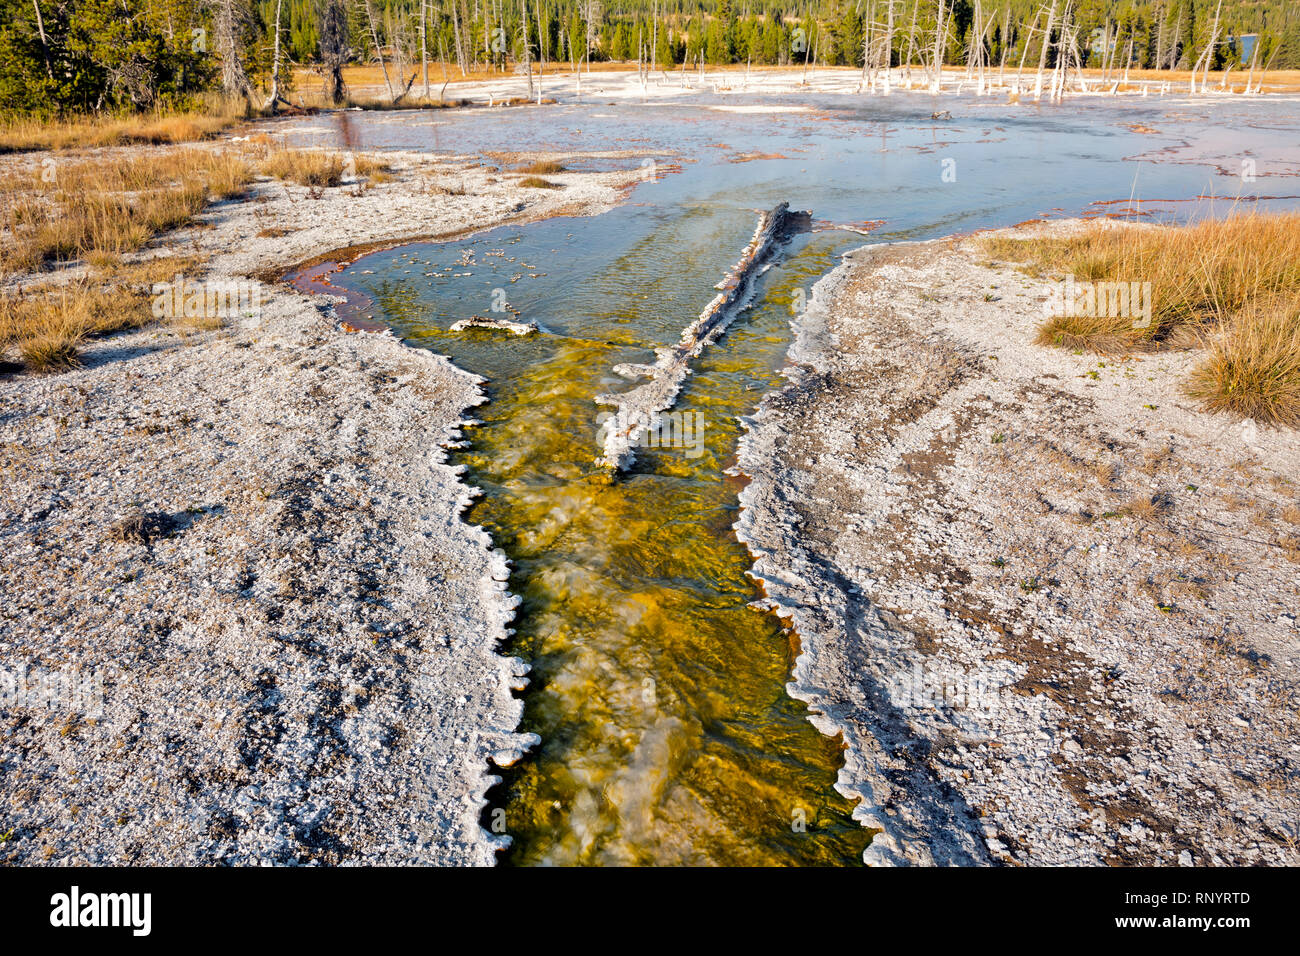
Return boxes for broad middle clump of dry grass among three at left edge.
[0,148,252,272]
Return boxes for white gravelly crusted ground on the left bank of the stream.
[0,143,637,864]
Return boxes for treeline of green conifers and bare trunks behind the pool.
[0,0,1300,114]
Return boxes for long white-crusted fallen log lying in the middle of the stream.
[595,203,811,472]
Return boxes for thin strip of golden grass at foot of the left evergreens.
[0,98,250,153]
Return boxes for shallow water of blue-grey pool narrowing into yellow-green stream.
[287,96,1300,864]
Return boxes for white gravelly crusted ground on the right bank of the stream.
[737,224,1300,865]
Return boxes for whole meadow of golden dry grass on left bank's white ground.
[0,137,405,372]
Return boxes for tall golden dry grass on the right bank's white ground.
[984,213,1300,427]
